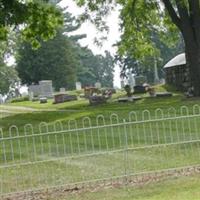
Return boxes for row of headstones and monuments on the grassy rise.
[8,74,173,108]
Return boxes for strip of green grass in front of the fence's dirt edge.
[58,175,200,200]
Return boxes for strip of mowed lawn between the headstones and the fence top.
[0,95,200,130]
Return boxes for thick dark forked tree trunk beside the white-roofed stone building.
[162,0,200,96]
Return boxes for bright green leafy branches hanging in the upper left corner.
[0,0,63,47]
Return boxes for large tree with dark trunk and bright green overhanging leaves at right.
[76,0,200,96]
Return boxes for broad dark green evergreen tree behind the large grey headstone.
[16,9,81,90]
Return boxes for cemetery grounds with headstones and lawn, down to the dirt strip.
[0,69,200,199]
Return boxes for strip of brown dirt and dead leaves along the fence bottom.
[1,166,200,200]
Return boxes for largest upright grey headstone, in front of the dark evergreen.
[39,80,53,98]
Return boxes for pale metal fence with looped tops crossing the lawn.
[0,105,200,196]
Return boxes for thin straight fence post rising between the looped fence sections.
[123,119,128,184]
